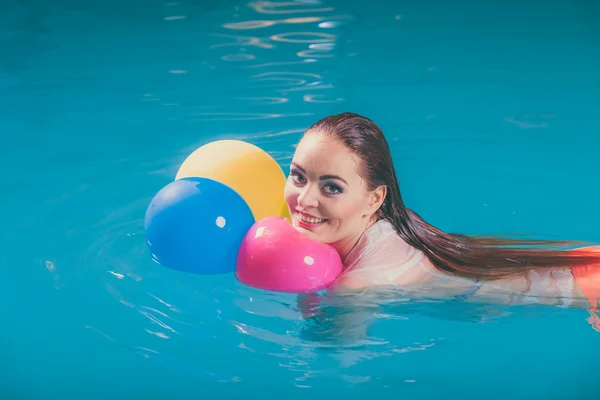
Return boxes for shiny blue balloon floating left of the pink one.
[144,177,255,275]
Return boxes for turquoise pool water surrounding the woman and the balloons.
[0,0,600,399]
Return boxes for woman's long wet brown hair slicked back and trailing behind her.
[305,112,600,280]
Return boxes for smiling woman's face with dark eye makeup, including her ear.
[284,132,385,258]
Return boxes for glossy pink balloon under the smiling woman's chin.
[235,217,342,293]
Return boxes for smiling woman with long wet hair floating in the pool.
[285,113,600,330]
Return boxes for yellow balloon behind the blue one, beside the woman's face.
[175,140,289,221]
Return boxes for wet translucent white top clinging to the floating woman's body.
[338,220,575,306]
